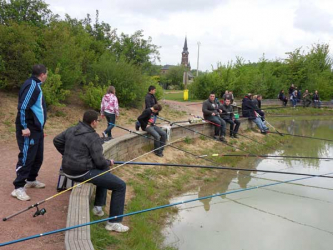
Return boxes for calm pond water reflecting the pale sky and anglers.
[164,117,333,250]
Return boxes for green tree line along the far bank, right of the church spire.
[189,43,333,100]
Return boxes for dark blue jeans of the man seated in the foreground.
[73,169,126,223]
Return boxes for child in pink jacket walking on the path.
[101,86,119,139]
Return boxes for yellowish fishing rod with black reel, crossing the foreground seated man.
[2,138,183,221]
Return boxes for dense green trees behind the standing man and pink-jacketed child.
[0,0,159,109]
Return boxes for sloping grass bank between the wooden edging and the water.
[91,130,285,250]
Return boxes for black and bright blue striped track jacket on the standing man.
[15,76,46,132]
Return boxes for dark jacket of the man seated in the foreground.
[53,122,111,176]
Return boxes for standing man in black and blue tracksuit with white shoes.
[11,64,47,201]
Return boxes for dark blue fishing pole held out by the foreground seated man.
[115,161,333,178]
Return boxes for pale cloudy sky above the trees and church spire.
[45,0,333,71]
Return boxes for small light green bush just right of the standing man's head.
[42,69,70,106]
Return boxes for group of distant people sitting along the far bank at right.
[278,84,321,108]
